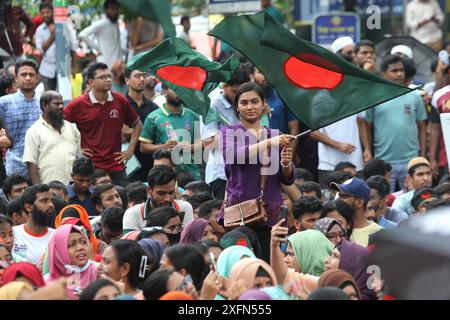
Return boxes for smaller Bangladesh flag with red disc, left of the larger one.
[127,38,239,124]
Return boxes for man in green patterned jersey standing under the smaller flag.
[139,85,202,179]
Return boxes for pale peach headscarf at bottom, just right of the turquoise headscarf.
[228,258,277,289]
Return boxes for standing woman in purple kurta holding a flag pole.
[219,82,295,261]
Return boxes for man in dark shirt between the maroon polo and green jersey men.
[122,68,158,181]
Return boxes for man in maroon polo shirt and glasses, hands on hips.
[64,62,142,186]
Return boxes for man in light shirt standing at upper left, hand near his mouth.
[36,2,77,91]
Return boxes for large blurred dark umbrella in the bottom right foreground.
[370,208,450,300]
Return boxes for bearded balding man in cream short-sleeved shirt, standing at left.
[22,91,82,185]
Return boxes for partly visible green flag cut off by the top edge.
[118,0,176,38]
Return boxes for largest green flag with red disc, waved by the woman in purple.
[209,11,411,130]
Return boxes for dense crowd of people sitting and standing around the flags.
[0,0,450,300]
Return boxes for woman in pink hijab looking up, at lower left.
[44,224,97,299]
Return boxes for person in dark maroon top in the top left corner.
[0,0,34,66]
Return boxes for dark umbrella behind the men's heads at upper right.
[375,35,437,83]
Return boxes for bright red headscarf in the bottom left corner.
[2,262,45,288]
